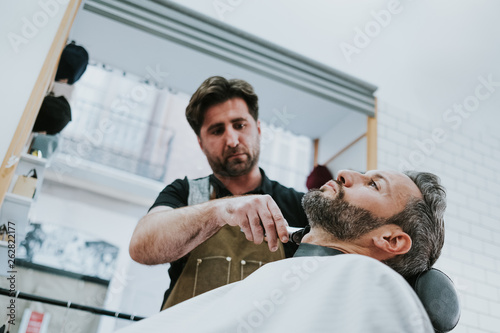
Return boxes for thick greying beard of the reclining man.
[302,183,385,241]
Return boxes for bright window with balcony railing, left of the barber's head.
[60,65,174,181]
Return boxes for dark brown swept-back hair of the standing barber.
[186,76,259,136]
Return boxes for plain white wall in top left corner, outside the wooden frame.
[0,0,68,166]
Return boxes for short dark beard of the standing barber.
[208,142,260,177]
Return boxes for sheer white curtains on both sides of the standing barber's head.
[61,65,312,191]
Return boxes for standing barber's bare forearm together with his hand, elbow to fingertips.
[129,195,288,265]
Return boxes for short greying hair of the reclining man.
[384,171,446,278]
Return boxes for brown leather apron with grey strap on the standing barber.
[162,177,285,310]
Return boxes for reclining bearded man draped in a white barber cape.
[119,171,458,333]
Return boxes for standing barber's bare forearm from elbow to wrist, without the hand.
[129,202,220,265]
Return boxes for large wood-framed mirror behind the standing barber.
[0,0,376,329]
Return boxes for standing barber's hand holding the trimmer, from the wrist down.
[218,194,288,252]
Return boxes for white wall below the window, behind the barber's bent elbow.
[30,180,170,332]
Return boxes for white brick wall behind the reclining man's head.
[378,102,500,333]
